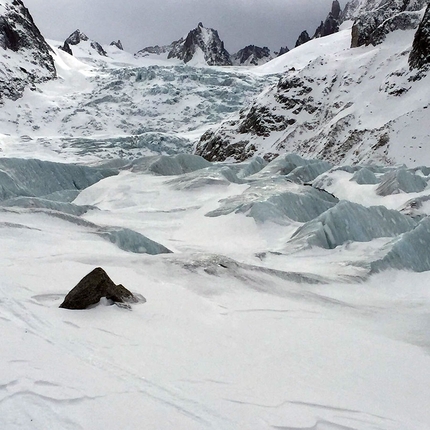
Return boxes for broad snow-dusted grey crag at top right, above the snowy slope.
[350,0,427,48]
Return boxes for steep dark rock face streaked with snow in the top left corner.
[0,0,56,103]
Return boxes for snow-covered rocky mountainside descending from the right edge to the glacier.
[196,1,430,164]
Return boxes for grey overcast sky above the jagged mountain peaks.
[23,0,336,53]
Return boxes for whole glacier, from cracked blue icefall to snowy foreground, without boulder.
[0,28,430,430]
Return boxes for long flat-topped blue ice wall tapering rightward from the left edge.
[0,158,118,201]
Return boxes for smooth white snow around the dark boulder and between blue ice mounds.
[0,152,430,430]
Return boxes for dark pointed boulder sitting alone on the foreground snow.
[60,267,138,310]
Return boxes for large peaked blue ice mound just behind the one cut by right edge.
[290,200,417,249]
